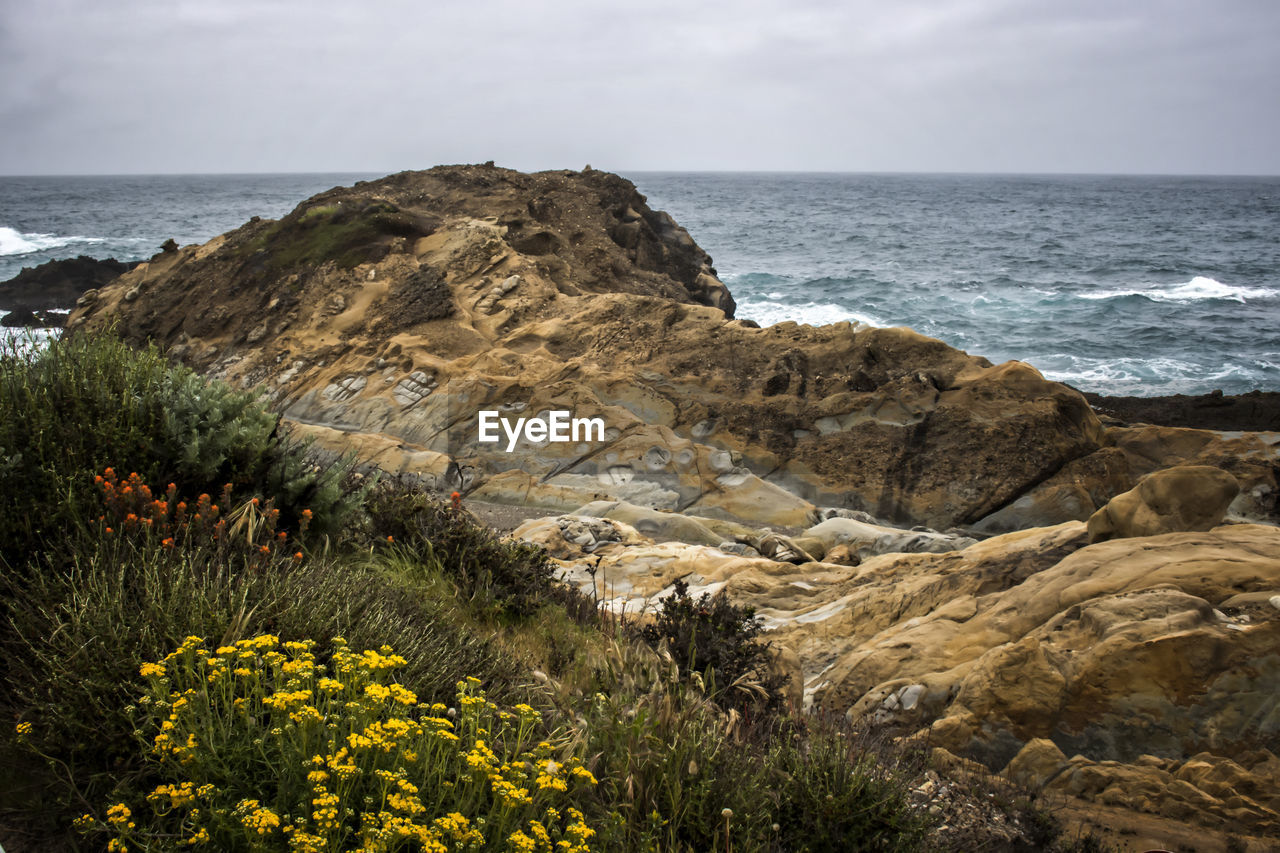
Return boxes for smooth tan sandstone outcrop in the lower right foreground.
[516,516,1280,835]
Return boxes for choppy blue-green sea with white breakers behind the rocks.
[0,172,1280,396]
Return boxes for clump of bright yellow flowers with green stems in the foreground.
[72,635,596,853]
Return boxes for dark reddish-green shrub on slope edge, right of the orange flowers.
[365,482,567,617]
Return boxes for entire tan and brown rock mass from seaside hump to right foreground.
[69,165,1280,833]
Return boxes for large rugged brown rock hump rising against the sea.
[72,167,1275,532]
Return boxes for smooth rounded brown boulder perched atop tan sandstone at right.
[1088,465,1240,542]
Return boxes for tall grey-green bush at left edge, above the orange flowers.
[0,334,358,566]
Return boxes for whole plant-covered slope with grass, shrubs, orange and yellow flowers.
[0,327,1075,853]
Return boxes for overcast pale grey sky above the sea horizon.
[0,0,1280,174]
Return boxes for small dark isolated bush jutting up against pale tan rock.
[639,580,783,710]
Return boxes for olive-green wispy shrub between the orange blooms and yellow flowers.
[0,512,516,831]
